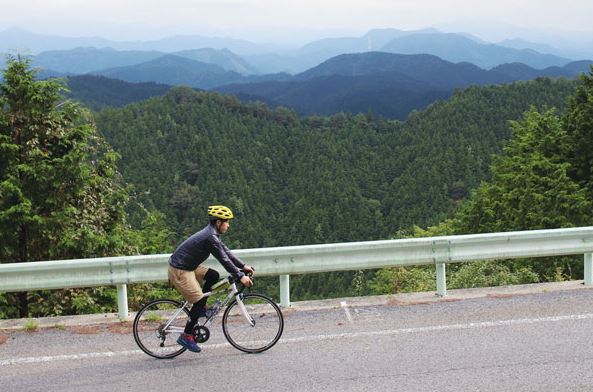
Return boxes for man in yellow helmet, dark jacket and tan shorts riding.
[169,205,254,353]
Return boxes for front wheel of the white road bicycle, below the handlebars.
[222,293,284,353]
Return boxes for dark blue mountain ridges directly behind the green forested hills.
[54,52,593,120]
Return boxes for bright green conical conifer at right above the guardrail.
[458,109,593,233]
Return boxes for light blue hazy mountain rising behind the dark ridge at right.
[382,34,570,68]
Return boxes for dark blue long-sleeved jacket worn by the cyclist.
[169,225,245,279]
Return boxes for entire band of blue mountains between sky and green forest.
[0,29,592,119]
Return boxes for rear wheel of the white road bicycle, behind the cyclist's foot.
[132,299,189,359]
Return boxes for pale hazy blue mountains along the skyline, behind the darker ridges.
[0,29,593,75]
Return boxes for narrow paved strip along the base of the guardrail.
[0,280,593,332]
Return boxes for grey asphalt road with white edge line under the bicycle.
[0,289,593,392]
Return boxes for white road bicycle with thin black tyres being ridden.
[132,276,284,359]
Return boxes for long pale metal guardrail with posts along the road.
[0,226,593,319]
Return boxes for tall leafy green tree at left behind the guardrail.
[0,57,169,317]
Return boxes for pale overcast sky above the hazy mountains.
[0,0,593,43]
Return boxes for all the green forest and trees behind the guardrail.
[0,54,593,318]
